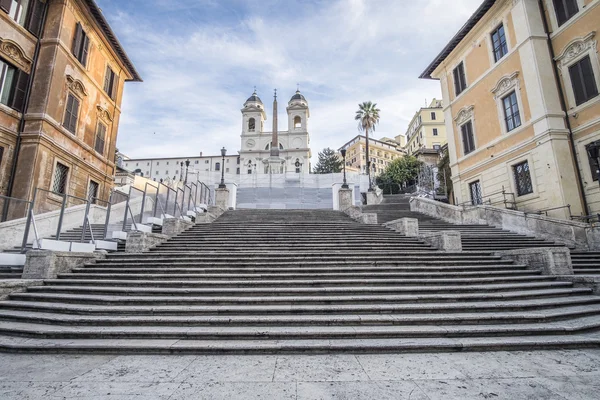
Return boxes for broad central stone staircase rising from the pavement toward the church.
[0,210,600,354]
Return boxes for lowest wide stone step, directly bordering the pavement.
[0,333,600,355]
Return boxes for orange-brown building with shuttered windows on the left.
[0,0,141,216]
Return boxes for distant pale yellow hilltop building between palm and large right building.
[396,99,447,156]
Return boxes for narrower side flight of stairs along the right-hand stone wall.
[363,195,600,275]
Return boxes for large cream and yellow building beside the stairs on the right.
[421,0,600,217]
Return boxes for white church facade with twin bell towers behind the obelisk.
[240,90,311,174]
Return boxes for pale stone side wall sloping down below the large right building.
[410,197,600,250]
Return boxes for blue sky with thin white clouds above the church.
[97,0,481,160]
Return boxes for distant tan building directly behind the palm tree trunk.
[338,135,404,175]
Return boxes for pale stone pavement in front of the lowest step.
[0,350,600,400]
